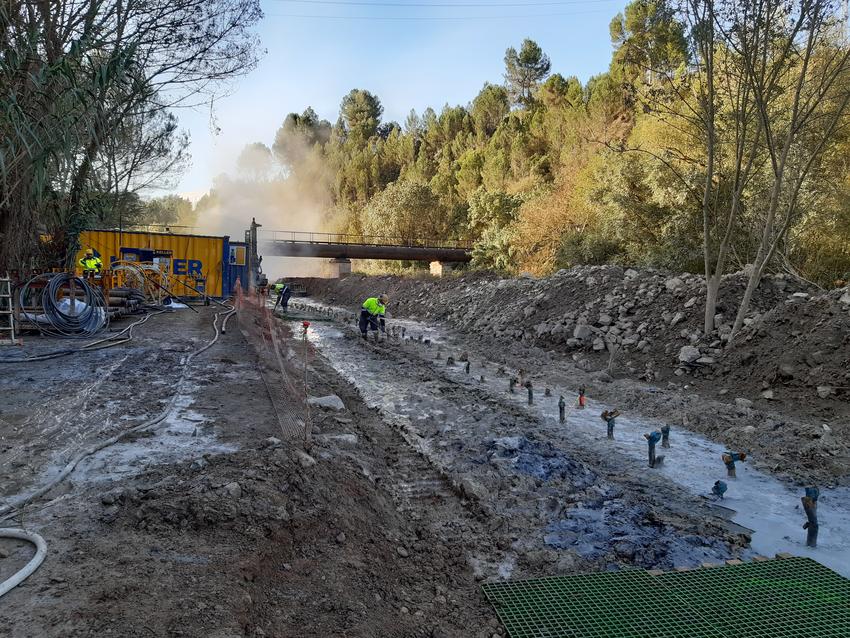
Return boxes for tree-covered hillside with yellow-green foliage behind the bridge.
[227,0,850,302]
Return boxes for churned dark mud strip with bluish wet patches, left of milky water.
[294,304,747,577]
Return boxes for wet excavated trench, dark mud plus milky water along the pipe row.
[284,301,850,577]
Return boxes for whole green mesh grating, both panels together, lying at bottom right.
[483,558,850,638]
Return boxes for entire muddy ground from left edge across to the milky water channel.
[0,298,747,638]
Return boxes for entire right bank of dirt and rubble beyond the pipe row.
[301,266,850,486]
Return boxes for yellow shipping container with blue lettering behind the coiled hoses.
[77,230,226,297]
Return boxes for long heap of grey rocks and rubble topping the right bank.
[300,266,836,394]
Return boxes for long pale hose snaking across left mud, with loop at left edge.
[0,304,236,597]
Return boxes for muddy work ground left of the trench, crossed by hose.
[0,311,496,638]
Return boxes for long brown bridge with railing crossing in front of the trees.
[258,230,472,263]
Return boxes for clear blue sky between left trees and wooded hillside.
[169,0,626,199]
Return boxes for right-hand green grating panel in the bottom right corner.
[659,558,850,638]
